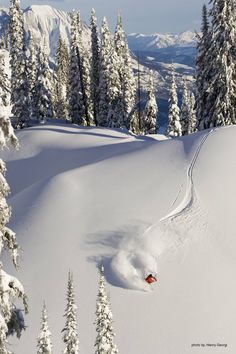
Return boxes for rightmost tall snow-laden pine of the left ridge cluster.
[114,15,136,130]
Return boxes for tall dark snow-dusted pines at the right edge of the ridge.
[196,0,236,130]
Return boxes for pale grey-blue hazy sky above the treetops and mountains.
[1,0,205,34]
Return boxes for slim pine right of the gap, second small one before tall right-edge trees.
[180,79,192,135]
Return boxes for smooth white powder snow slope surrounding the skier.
[4,121,236,354]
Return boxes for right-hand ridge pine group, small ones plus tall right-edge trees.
[164,0,236,136]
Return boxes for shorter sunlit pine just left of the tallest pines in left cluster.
[54,36,69,118]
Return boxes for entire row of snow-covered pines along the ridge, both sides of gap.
[0,0,236,136]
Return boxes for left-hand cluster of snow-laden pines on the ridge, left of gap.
[2,0,157,133]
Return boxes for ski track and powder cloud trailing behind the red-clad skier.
[110,129,213,291]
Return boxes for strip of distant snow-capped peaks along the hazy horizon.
[128,31,196,51]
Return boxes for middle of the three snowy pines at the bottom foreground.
[62,272,79,354]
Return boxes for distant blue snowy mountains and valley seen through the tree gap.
[127,31,196,100]
